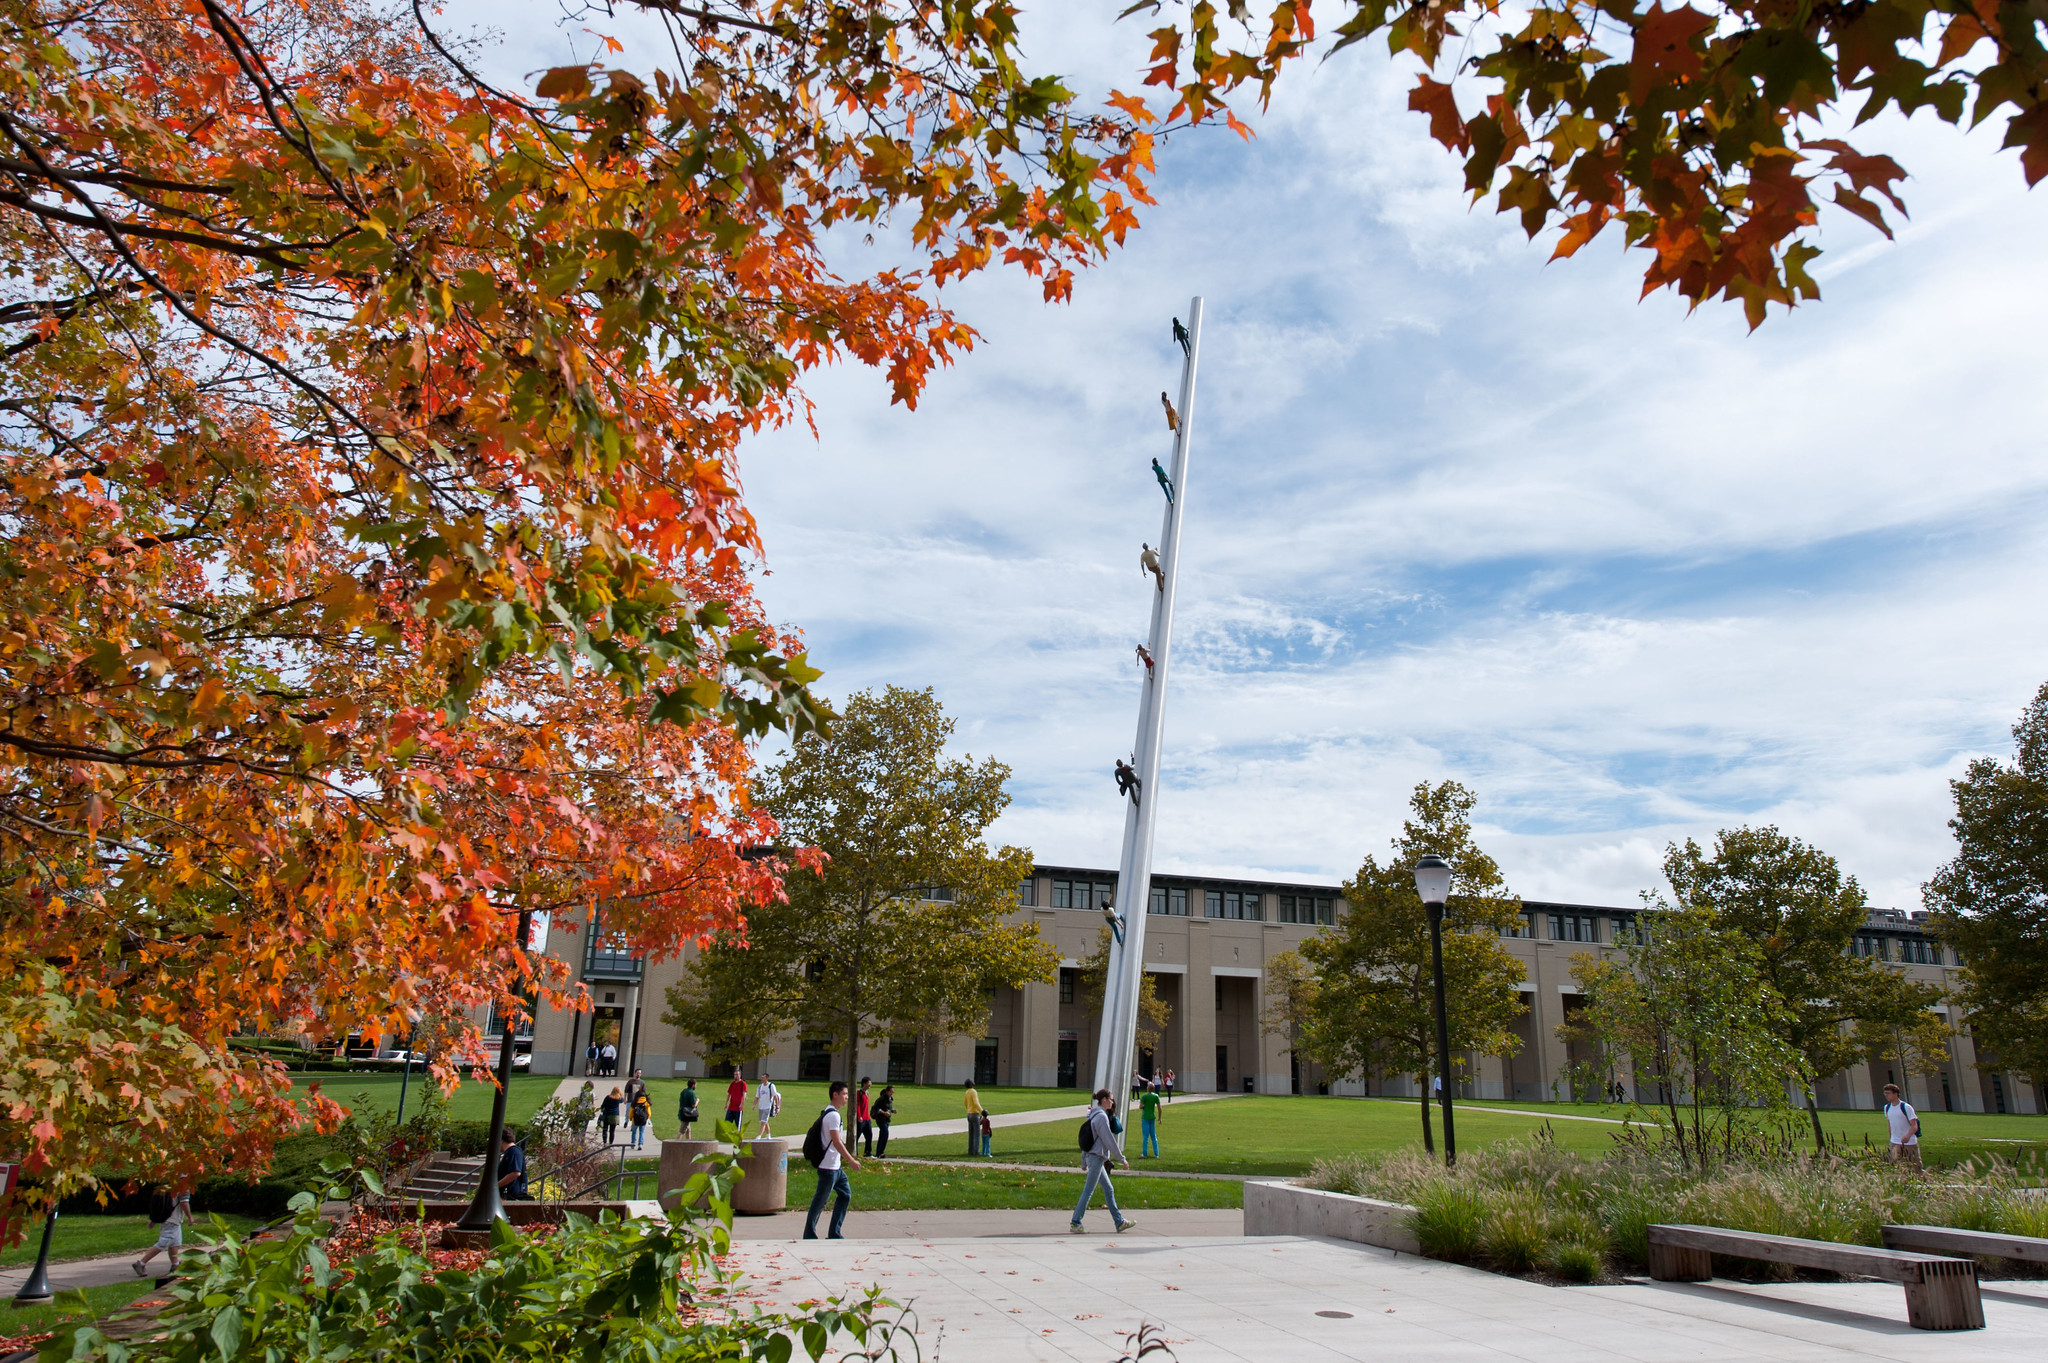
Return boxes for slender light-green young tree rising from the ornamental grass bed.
[1571,896,1800,1171]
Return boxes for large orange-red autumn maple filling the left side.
[0,0,1149,1193]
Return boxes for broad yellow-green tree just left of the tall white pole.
[664,686,1059,1079]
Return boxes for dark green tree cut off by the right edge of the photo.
[1921,686,2048,1083]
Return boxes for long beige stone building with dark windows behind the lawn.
[530,866,2044,1113]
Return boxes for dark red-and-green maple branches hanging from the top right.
[1133,0,2048,325]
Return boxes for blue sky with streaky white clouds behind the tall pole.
[471,4,2048,909]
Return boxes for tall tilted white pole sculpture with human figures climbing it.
[1096,299,1202,1103]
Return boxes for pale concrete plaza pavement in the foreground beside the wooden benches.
[733,1214,2048,1363]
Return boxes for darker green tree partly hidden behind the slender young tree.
[1663,827,1944,1150]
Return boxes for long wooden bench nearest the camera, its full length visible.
[1649,1226,1985,1330]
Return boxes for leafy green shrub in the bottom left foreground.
[45,1154,907,1363]
